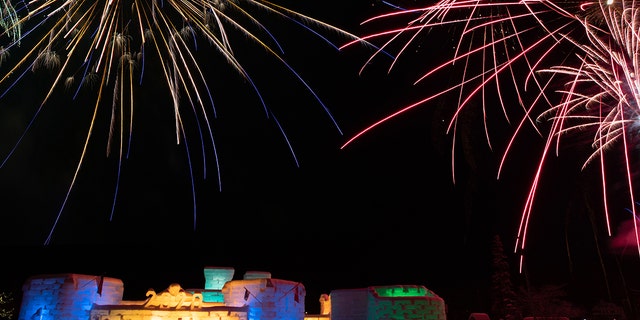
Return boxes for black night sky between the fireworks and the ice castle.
[0,1,638,318]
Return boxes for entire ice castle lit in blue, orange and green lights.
[13,267,446,320]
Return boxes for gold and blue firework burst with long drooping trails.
[0,0,370,244]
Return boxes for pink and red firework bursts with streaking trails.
[342,0,640,261]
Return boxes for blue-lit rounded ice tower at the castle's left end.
[18,274,124,320]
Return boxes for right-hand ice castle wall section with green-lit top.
[331,285,447,320]
